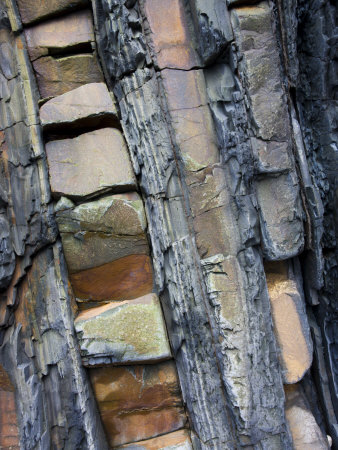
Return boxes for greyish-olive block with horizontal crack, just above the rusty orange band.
[56,193,149,277]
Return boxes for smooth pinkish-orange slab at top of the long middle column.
[145,0,199,69]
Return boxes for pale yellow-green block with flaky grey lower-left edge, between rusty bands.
[75,294,171,367]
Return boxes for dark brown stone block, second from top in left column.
[33,54,103,98]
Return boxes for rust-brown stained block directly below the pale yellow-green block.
[89,361,186,449]
